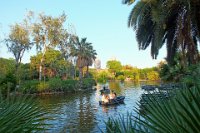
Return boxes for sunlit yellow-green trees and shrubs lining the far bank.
[91,60,160,82]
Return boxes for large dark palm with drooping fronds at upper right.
[123,0,200,65]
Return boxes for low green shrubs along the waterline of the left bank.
[17,78,96,94]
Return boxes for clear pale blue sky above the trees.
[0,0,166,68]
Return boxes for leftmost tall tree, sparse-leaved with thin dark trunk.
[5,23,32,82]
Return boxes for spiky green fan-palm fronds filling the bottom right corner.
[106,87,200,133]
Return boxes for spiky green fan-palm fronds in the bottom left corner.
[0,97,48,133]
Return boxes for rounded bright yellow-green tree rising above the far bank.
[106,60,122,77]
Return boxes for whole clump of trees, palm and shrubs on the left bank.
[0,11,97,94]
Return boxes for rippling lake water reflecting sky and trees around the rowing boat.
[36,82,157,133]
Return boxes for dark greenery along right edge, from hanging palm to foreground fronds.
[106,0,200,133]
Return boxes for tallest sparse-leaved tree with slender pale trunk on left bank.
[32,14,67,80]
